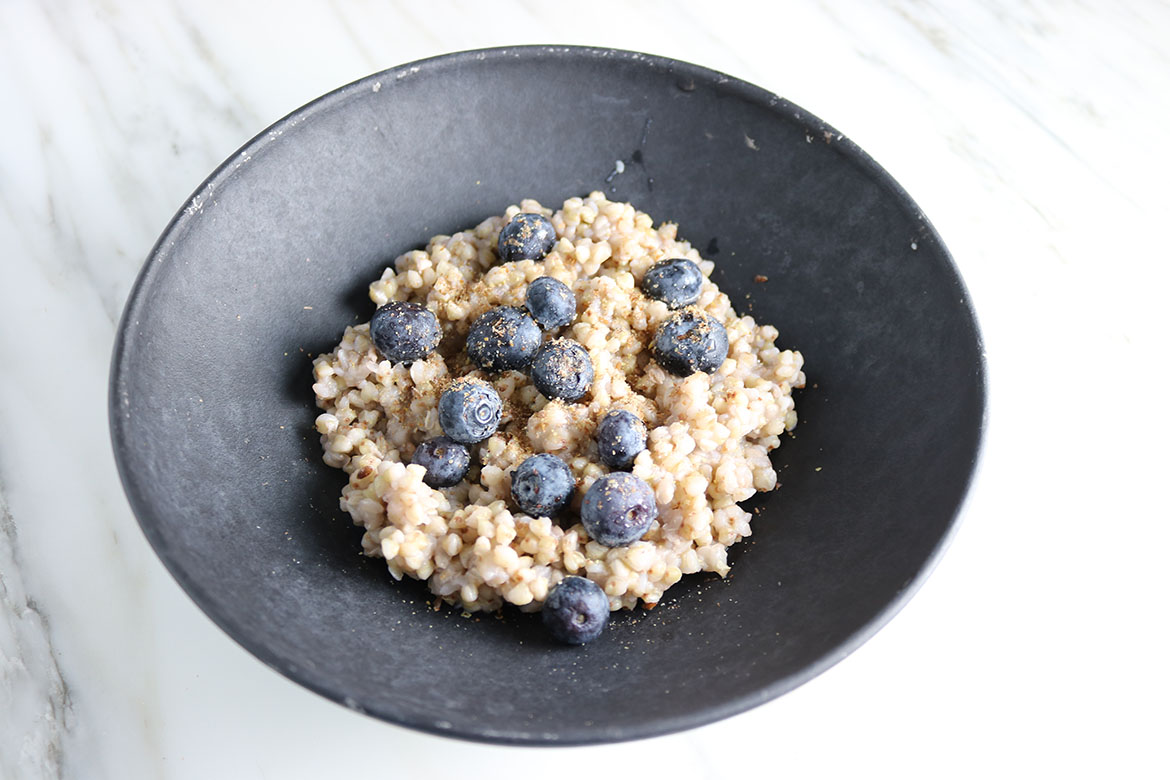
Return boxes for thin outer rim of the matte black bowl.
[108,44,989,746]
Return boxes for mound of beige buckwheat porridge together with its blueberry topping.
[314,192,805,643]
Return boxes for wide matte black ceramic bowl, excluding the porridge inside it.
[110,47,985,744]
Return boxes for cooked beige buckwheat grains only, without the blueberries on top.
[314,192,805,612]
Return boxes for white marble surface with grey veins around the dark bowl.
[0,0,1170,780]
